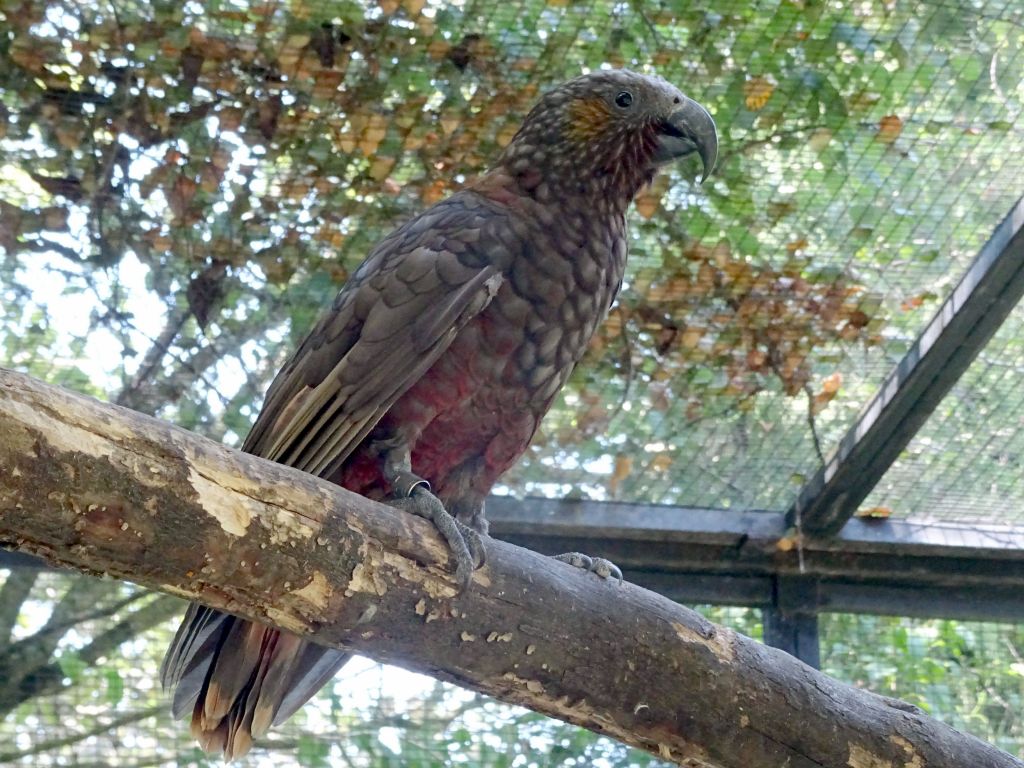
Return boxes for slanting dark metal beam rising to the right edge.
[786,199,1024,537]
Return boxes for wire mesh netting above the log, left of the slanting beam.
[3,0,1022,524]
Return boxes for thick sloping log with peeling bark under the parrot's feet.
[0,370,1024,768]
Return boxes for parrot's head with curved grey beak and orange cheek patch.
[491,70,718,202]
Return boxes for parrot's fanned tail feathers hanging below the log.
[160,604,349,760]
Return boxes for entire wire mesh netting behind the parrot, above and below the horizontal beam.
[0,0,1024,767]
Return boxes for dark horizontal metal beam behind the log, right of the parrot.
[487,497,1024,631]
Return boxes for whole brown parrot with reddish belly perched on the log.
[161,71,718,759]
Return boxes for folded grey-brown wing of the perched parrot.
[243,195,502,477]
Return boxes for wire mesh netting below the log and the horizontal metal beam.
[8,569,1024,766]
